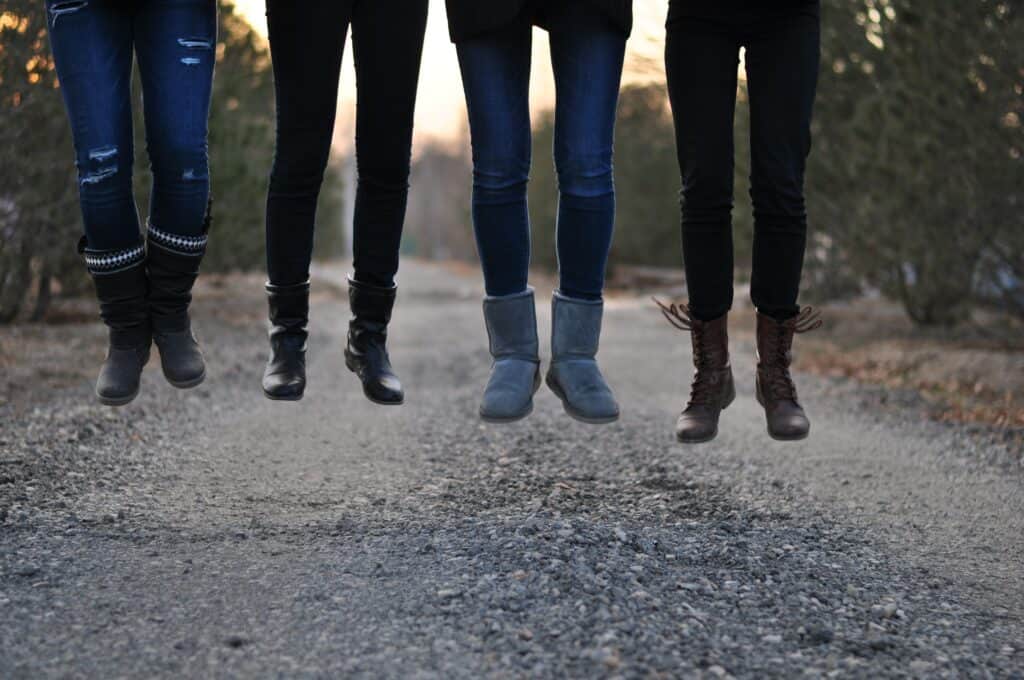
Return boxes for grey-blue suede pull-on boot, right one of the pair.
[547,291,618,425]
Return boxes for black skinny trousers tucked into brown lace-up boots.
[666,0,820,321]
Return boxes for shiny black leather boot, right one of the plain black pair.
[345,278,406,406]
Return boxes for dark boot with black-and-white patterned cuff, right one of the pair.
[145,213,210,389]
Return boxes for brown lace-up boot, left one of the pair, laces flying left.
[654,300,736,443]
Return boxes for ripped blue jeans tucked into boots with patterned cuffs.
[46,0,217,250]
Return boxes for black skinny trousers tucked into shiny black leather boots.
[266,0,427,286]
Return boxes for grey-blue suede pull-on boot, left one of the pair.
[480,288,541,423]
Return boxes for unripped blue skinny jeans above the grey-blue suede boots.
[458,0,626,299]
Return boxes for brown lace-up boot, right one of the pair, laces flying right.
[757,307,821,441]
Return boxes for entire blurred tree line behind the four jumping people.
[0,0,1024,325]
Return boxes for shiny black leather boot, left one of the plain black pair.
[263,281,309,401]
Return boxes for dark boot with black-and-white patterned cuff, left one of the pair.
[79,238,153,407]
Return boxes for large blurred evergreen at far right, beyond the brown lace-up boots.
[808,0,1024,325]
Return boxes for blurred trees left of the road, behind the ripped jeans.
[0,0,341,323]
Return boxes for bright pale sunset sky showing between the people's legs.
[228,0,668,146]
